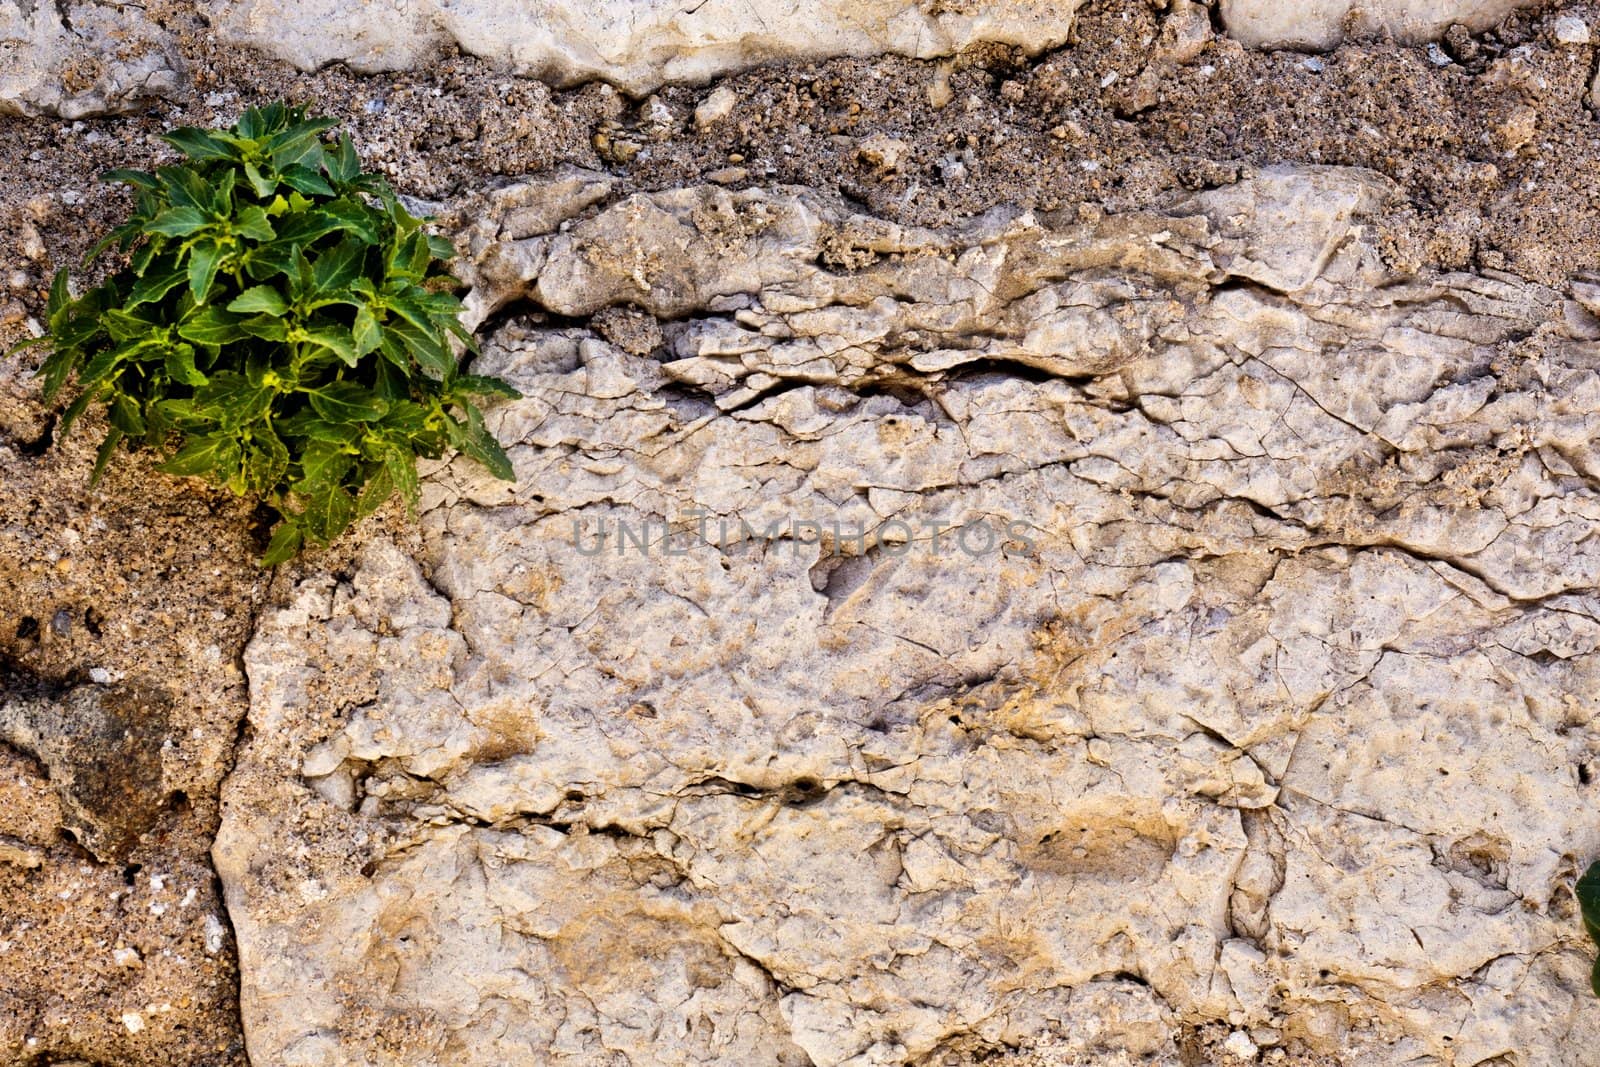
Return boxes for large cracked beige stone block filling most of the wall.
[214,168,1600,1067]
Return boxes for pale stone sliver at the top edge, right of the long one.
[1219,0,1542,50]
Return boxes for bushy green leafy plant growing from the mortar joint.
[6,104,518,565]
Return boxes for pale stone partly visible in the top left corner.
[0,0,181,118]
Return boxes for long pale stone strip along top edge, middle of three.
[208,0,1078,93]
